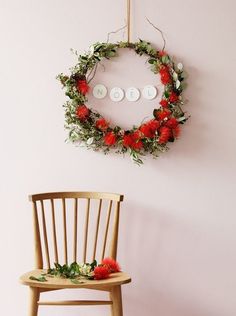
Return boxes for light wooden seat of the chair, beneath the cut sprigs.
[20,269,131,290]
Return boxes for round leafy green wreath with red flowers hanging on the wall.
[57,40,187,164]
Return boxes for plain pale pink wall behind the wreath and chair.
[0,0,236,316]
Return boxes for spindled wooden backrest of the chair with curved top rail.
[29,192,123,269]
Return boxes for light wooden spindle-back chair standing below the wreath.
[20,192,131,316]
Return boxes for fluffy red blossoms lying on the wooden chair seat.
[94,258,120,280]
